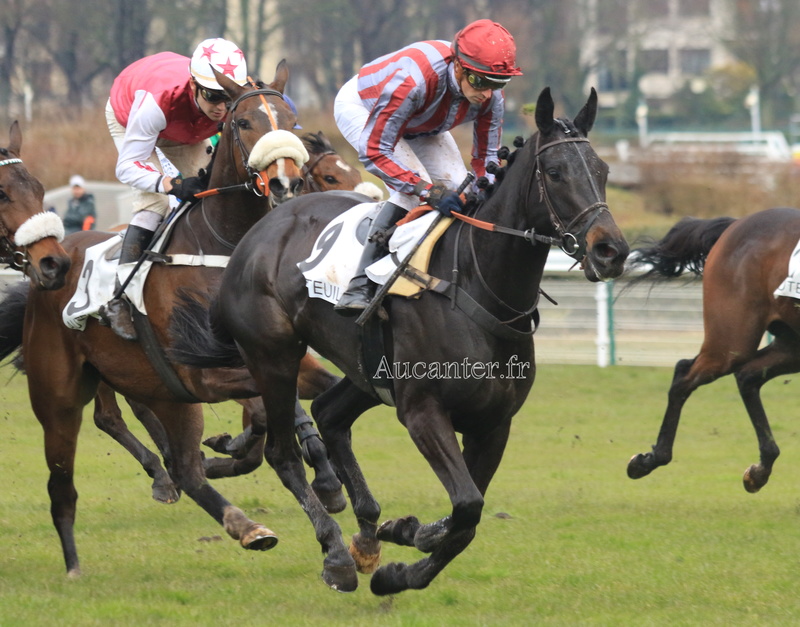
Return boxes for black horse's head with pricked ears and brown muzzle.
[526,87,630,281]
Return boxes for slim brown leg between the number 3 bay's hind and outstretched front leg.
[94,384,179,503]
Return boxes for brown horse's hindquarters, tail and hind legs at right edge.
[628,207,800,493]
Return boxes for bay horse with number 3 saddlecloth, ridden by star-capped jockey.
[0,61,340,576]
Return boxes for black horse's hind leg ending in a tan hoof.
[311,379,381,574]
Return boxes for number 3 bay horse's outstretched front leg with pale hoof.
[148,401,278,551]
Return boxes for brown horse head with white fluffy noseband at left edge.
[0,122,71,290]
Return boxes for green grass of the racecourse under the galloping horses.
[0,365,800,627]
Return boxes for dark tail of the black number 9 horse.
[169,289,244,368]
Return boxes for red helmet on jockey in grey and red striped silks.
[450,20,522,82]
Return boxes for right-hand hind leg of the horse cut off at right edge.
[736,336,800,493]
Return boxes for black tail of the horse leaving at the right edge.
[631,218,736,282]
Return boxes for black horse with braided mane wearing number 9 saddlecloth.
[172,88,629,595]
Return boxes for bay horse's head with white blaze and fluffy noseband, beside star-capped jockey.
[209,60,308,209]
